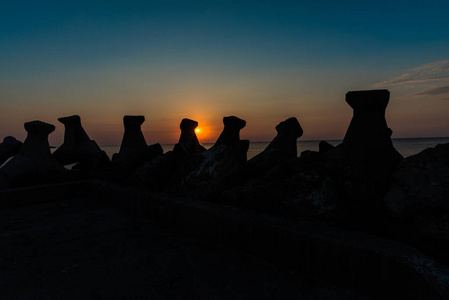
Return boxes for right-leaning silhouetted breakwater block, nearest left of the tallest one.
[248,117,303,173]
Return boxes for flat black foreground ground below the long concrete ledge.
[0,197,372,299]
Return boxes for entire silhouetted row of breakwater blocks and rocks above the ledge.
[0,90,449,262]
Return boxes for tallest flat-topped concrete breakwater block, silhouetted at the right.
[323,90,403,230]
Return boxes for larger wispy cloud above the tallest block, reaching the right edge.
[374,60,449,87]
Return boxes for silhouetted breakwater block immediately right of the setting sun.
[185,116,249,197]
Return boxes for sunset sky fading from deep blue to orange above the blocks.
[0,0,449,146]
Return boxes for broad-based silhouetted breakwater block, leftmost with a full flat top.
[0,121,69,187]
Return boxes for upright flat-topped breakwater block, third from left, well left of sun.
[112,116,163,177]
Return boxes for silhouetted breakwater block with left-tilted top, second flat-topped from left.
[53,115,110,170]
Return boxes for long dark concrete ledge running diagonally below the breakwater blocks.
[0,180,449,299]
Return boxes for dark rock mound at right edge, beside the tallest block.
[384,144,449,264]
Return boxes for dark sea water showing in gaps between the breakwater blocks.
[101,137,449,159]
